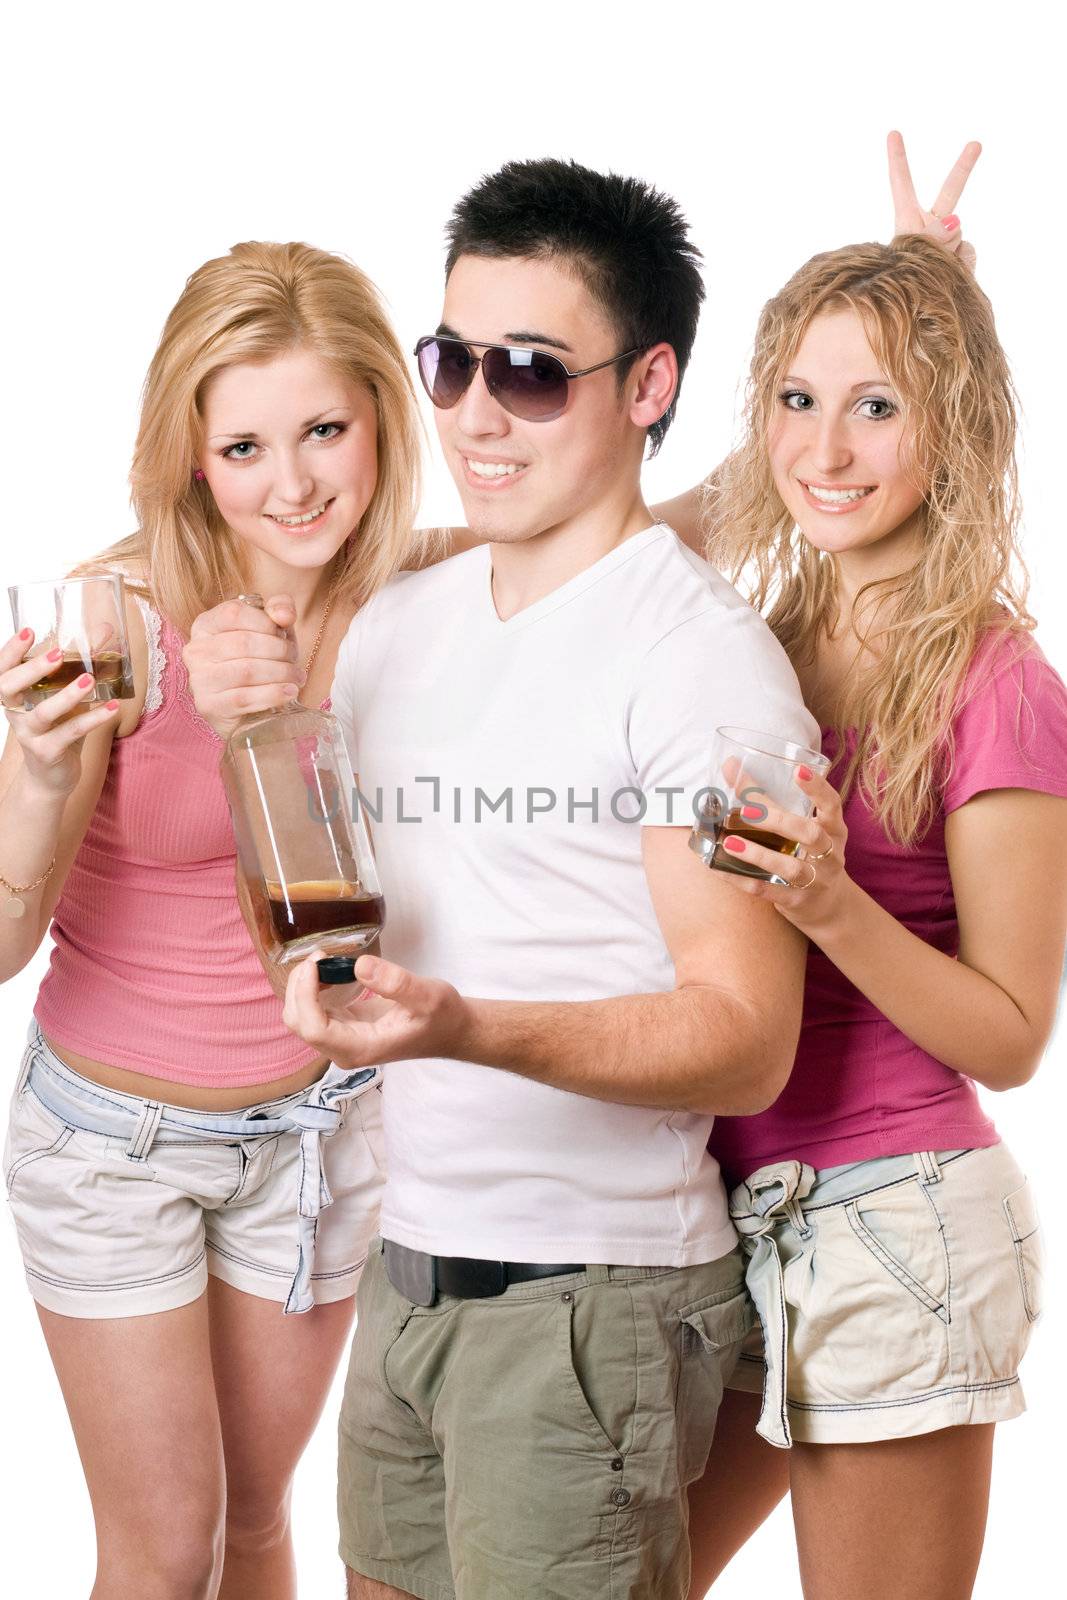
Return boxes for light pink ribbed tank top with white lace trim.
[34,608,317,1088]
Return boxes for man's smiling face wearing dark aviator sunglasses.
[434,256,659,542]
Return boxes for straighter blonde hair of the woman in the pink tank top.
[85,243,432,634]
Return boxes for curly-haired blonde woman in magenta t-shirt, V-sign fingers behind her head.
[691,136,1067,1600]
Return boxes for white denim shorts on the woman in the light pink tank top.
[3,1026,384,1317]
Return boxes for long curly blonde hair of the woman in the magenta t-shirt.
[704,234,1033,845]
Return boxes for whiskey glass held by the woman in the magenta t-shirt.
[689,728,830,885]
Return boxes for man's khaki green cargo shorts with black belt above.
[339,1242,753,1600]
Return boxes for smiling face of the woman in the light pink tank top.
[198,349,378,582]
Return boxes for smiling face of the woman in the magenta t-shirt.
[768,310,925,573]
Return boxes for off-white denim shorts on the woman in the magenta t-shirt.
[728,1144,1041,1448]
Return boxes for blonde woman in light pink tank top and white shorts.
[0,245,438,1600]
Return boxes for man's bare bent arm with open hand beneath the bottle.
[285,827,806,1115]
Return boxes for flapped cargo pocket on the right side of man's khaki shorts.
[675,1290,757,1488]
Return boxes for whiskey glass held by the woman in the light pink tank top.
[8,574,133,710]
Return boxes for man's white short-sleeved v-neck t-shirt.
[333,525,817,1267]
